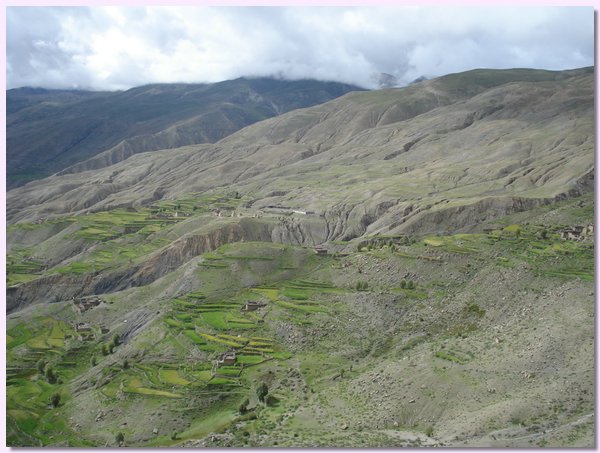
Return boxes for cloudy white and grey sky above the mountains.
[6,6,594,90]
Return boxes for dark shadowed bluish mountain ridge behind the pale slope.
[7,78,360,188]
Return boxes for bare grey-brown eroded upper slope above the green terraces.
[7,70,594,239]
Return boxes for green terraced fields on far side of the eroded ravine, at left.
[7,194,243,287]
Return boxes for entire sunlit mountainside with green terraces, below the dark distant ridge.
[6,68,595,448]
